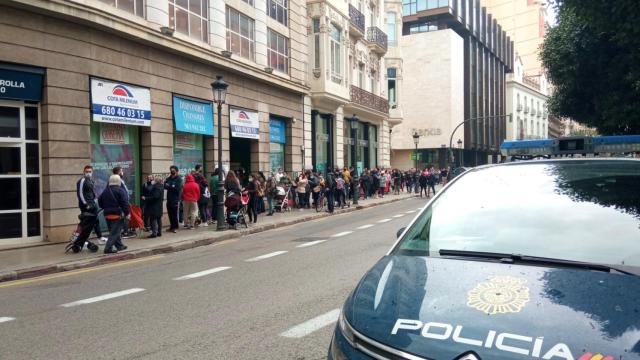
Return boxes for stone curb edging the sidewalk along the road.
[0,196,413,283]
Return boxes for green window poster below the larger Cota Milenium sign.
[91,144,137,201]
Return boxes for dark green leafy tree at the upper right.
[540,0,640,134]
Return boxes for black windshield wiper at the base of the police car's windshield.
[439,249,640,276]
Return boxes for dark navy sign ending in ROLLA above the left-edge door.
[0,69,42,101]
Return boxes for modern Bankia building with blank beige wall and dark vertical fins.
[391,0,513,168]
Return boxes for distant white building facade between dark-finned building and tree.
[507,55,549,140]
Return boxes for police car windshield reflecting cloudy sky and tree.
[394,160,640,267]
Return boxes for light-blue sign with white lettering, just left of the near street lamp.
[173,96,213,135]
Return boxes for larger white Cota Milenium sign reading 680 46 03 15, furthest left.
[91,79,151,126]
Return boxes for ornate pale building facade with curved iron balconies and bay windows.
[304,0,389,172]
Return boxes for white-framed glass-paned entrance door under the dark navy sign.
[0,101,42,244]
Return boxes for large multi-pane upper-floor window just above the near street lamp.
[227,7,256,61]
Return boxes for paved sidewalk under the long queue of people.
[0,193,424,282]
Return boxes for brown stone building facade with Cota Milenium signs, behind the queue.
[0,0,309,246]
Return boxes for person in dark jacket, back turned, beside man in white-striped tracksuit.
[98,174,131,254]
